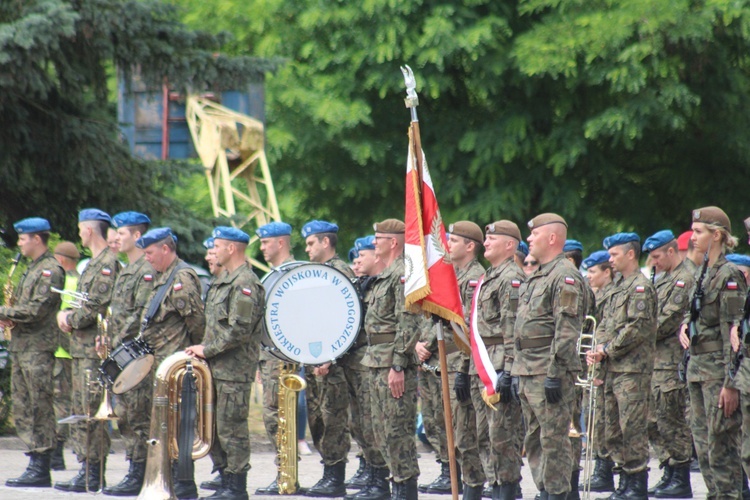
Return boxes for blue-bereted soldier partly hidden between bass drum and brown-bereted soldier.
[344,236,391,500]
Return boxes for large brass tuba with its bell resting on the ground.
[138,352,213,500]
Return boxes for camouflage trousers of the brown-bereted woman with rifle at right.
[688,380,742,500]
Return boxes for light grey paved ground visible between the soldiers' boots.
[0,438,706,500]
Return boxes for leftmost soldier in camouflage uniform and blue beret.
[0,217,65,487]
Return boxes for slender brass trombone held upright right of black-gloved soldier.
[571,316,597,499]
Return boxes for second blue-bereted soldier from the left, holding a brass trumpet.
[55,208,120,493]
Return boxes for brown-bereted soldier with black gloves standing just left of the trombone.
[511,213,585,500]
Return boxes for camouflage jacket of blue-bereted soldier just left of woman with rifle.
[654,263,695,376]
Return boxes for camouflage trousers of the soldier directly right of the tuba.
[211,380,256,474]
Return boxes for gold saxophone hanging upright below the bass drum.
[276,363,307,495]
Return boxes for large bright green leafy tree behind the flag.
[174,0,750,247]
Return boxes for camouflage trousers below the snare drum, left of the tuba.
[115,373,154,462]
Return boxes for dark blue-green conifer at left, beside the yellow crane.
[0,0,275,262]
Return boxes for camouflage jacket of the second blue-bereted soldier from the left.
[68,249,120,359]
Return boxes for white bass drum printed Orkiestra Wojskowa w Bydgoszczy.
[261,262,363,365]
